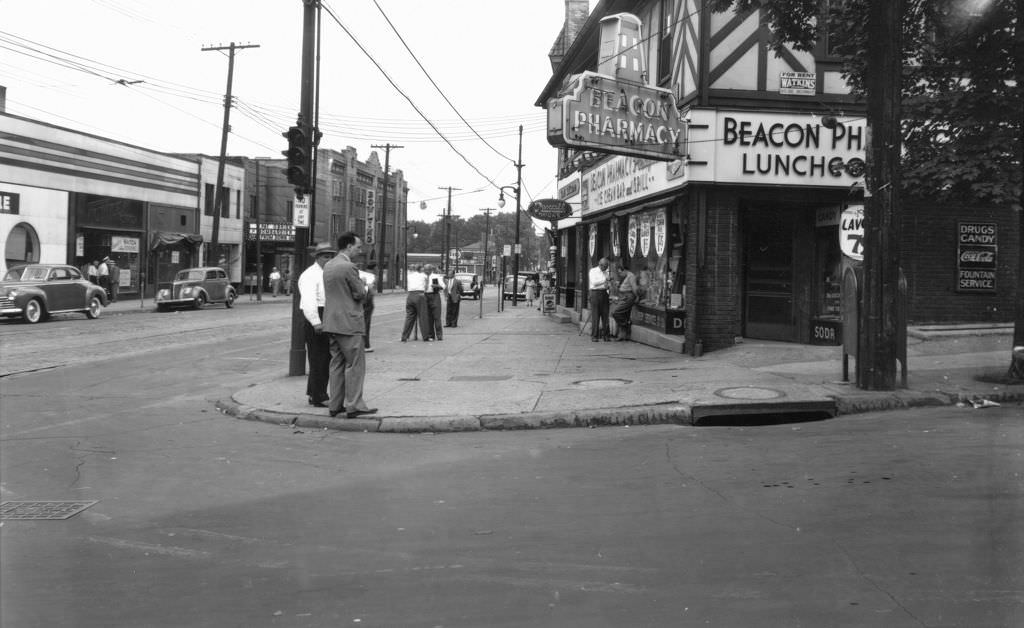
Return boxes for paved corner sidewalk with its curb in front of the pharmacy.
[211,303,1024,432]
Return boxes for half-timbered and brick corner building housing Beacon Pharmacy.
[537,0,1019,351]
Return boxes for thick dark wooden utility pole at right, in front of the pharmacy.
[856,0,906,390]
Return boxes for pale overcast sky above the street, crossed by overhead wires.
[0,0,597,230]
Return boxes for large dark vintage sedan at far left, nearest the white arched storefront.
[0,264,106,323]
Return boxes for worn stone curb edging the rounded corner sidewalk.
[215,390,1024,433]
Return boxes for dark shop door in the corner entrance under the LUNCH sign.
[743,209,797,341]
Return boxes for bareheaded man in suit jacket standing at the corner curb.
[324,232,377,419]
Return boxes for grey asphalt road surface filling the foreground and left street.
[0,295,1024,628]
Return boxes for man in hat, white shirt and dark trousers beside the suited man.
[299,242,338,408]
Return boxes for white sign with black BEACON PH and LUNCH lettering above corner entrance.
[687,109,867,186]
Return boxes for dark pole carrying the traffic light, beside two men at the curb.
[285,0,319,376]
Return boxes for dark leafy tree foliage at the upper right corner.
[712,0,1024,208]
